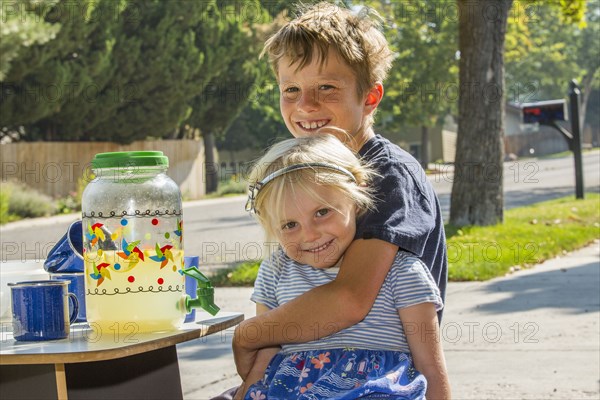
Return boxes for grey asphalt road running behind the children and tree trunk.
[0,150,600,269]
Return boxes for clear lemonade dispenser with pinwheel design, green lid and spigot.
[82,151,218,333]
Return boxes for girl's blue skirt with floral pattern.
[245,349,427,400]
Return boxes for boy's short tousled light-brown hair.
[261,2,394,98]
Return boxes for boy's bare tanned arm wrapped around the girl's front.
[233,239,398,377]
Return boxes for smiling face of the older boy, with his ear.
[278,49,376,151]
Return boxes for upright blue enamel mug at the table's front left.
[8,280,79,341]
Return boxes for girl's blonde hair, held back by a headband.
[248,135,377,250]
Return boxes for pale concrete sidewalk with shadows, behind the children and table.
[178,242,600,400]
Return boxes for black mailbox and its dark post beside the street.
[521,80,584,199]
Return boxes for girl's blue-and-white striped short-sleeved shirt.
[251,250,443,353]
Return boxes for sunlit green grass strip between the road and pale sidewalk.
[216,193,600,287]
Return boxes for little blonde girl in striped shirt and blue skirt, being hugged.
[237,135,450,400]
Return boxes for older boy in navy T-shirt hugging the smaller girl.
[233,3,447,395]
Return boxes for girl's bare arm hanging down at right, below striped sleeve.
[399,303,452,400]
